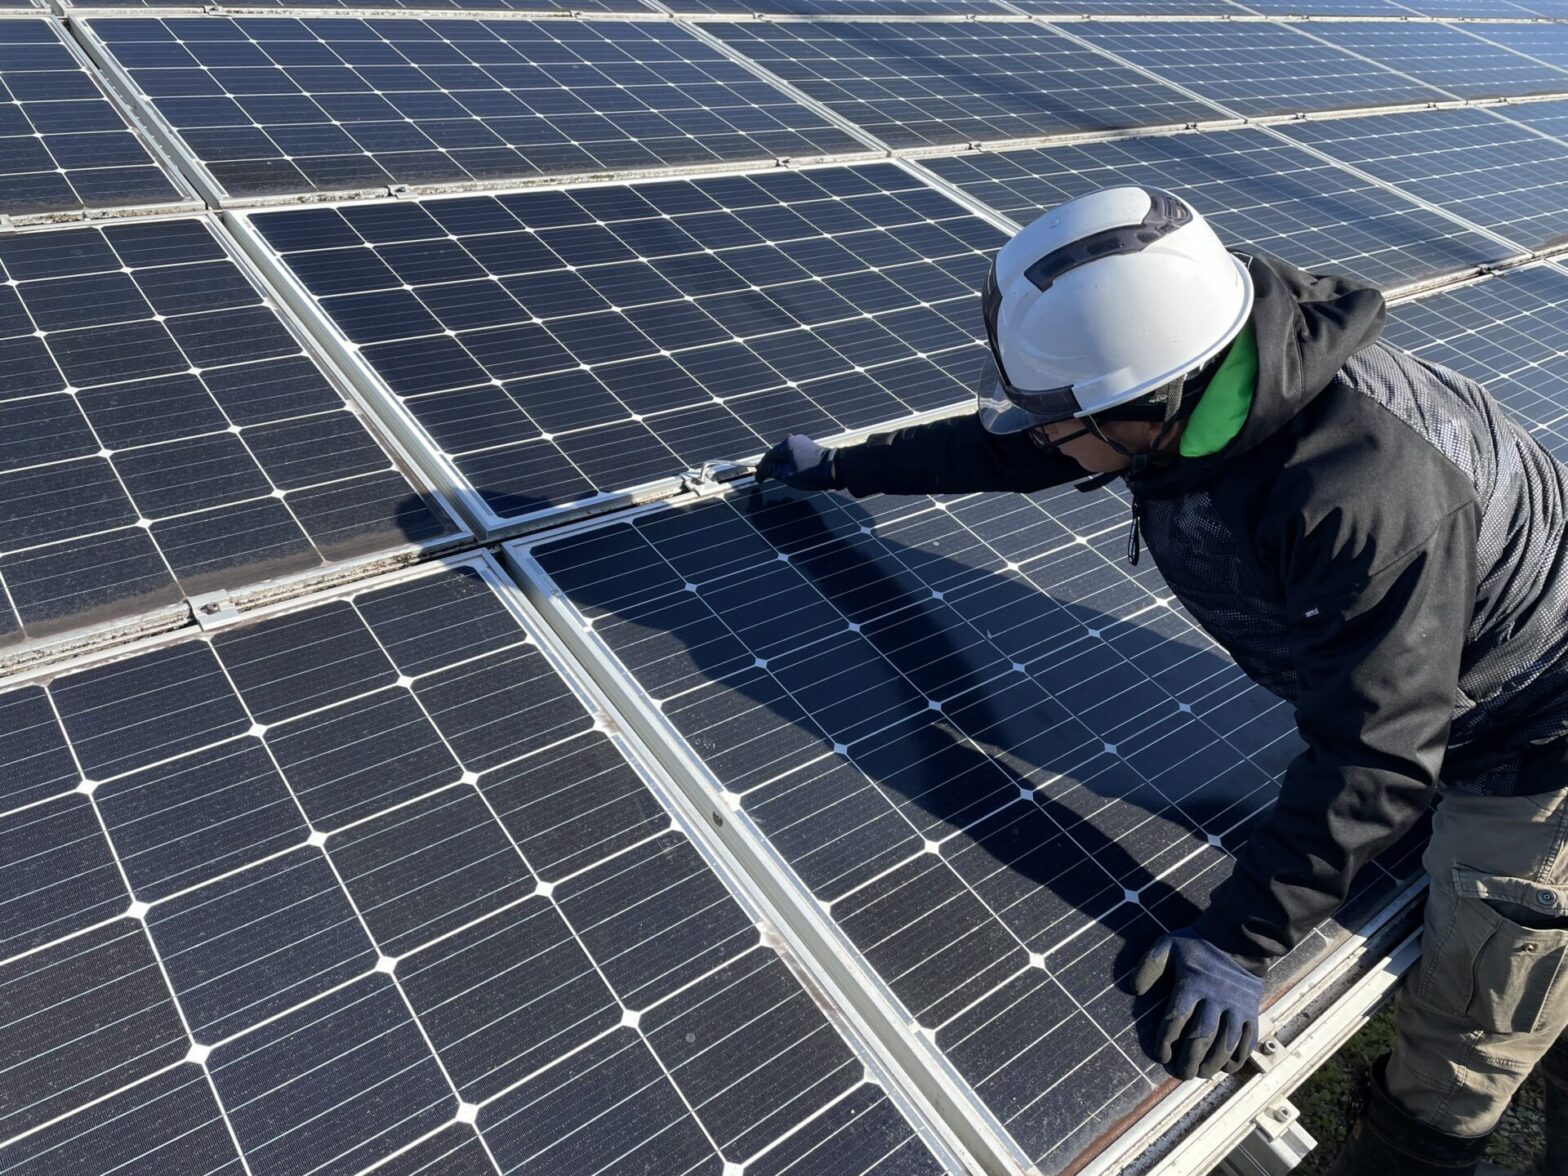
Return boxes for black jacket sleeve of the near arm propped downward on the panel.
[1196,502,1479,975]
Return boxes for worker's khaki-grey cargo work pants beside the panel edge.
[1386,790,1568,1135]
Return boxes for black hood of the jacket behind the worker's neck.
[1138,256,1385,494]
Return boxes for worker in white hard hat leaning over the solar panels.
[757,187,1568,1176]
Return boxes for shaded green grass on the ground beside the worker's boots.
[1290,1007,1543,1176]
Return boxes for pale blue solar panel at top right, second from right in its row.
[1309,20,1568,97]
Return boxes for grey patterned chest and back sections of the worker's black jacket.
[1143,343,1568,795]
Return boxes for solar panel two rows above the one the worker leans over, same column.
[86,16,864,201]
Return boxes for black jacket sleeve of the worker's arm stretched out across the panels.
[834,414,1085,499]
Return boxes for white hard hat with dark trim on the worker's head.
[975,187,1253,433]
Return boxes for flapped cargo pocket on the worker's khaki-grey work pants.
[1421,866,1568,1033]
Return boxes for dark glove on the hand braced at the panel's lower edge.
[1132,930,1264,1079]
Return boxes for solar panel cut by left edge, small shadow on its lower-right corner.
[0,220,456,655]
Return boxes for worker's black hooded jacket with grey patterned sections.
[837,259,1568,972]
